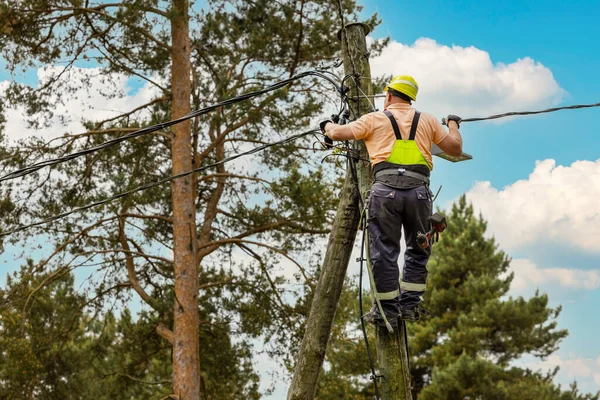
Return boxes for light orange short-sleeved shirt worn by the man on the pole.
[330,103,449,169]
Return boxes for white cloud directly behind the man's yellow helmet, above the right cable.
[371,38,565,118]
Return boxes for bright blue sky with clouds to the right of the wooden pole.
[361,0,600,391]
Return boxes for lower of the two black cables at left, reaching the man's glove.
[0,129,317,238]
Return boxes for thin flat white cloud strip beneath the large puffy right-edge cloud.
[510,258,600,290]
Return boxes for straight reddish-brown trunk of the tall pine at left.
[171,0,200,400]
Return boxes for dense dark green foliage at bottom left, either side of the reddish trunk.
[0,263,260,400]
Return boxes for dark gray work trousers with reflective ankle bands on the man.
[368,182,432,315]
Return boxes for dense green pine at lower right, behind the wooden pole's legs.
[317,196,599,400]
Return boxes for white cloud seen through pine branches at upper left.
[0,66,159,140]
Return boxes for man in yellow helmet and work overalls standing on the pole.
[320,75,462,327]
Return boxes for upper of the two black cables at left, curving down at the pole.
[0,71,342,182]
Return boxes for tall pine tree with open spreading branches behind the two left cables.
[0,0,382,396]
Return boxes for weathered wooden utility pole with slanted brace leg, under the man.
[287,23,412,400]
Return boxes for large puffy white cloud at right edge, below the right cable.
[466,159,600,253]
